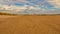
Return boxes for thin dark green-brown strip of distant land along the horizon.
[0,13,60,16]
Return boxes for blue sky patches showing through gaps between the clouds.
[15,0,53,9]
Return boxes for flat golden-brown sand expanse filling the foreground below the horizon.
[0,15,60,34]
